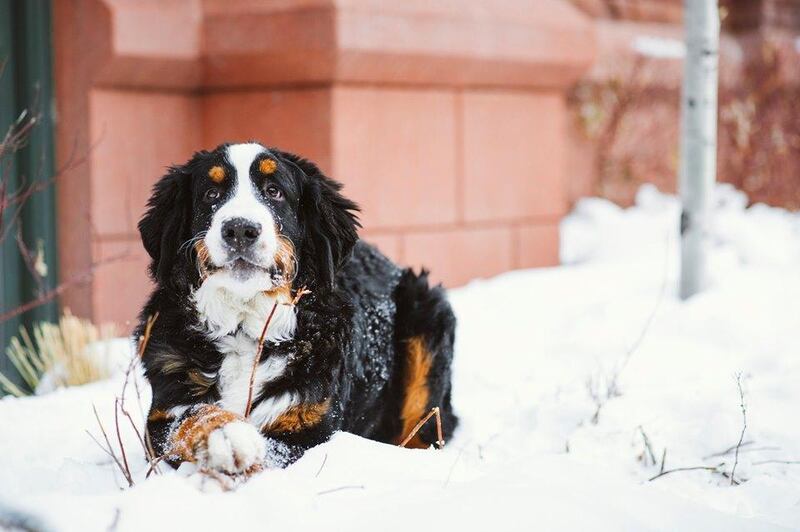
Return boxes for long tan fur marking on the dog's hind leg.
[395,336,431,449]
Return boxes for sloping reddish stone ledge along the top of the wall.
[80,0,595,91]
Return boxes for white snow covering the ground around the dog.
[0,187,800,531]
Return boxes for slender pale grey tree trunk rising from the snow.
[679,0,719,299]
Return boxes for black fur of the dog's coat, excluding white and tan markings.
[137,145,457,463]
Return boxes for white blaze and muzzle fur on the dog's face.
[204,143,278,276]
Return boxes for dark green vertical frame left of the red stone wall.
[0,0,58,390]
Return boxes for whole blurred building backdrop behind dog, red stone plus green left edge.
[0,0,800,344]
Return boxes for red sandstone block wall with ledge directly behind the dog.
[55,0,594,330]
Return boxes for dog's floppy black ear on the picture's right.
[276,150,361,288]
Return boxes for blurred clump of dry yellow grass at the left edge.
[0,310,114,397]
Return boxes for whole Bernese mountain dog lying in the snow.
[135,143,457,474]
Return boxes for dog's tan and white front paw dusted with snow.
[172,405,266,474]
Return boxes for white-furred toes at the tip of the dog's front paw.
[204,421,266,473]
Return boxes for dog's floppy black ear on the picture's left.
[139,166,192,286]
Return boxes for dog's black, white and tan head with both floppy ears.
[139,143,359,296]
